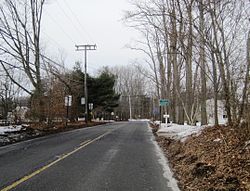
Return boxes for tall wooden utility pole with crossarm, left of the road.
[75,44,96,124]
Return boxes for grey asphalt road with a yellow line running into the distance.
[0,122,176,191]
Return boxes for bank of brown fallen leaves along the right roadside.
[153,123,250,191]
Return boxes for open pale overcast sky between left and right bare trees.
[42,0,142,73]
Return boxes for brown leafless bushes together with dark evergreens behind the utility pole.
[29,63,120,122]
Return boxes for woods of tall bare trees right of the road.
[124,0,250,124]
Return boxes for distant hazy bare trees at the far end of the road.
[111,64,152,119]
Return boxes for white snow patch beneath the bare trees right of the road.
[157,124,205,141]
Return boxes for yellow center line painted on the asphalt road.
[0,132,110,191]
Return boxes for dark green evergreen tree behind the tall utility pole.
[67,63,120,117]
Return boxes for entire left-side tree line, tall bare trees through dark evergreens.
[0,0,119,121]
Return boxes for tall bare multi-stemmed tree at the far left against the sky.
[0,0,45,95]
